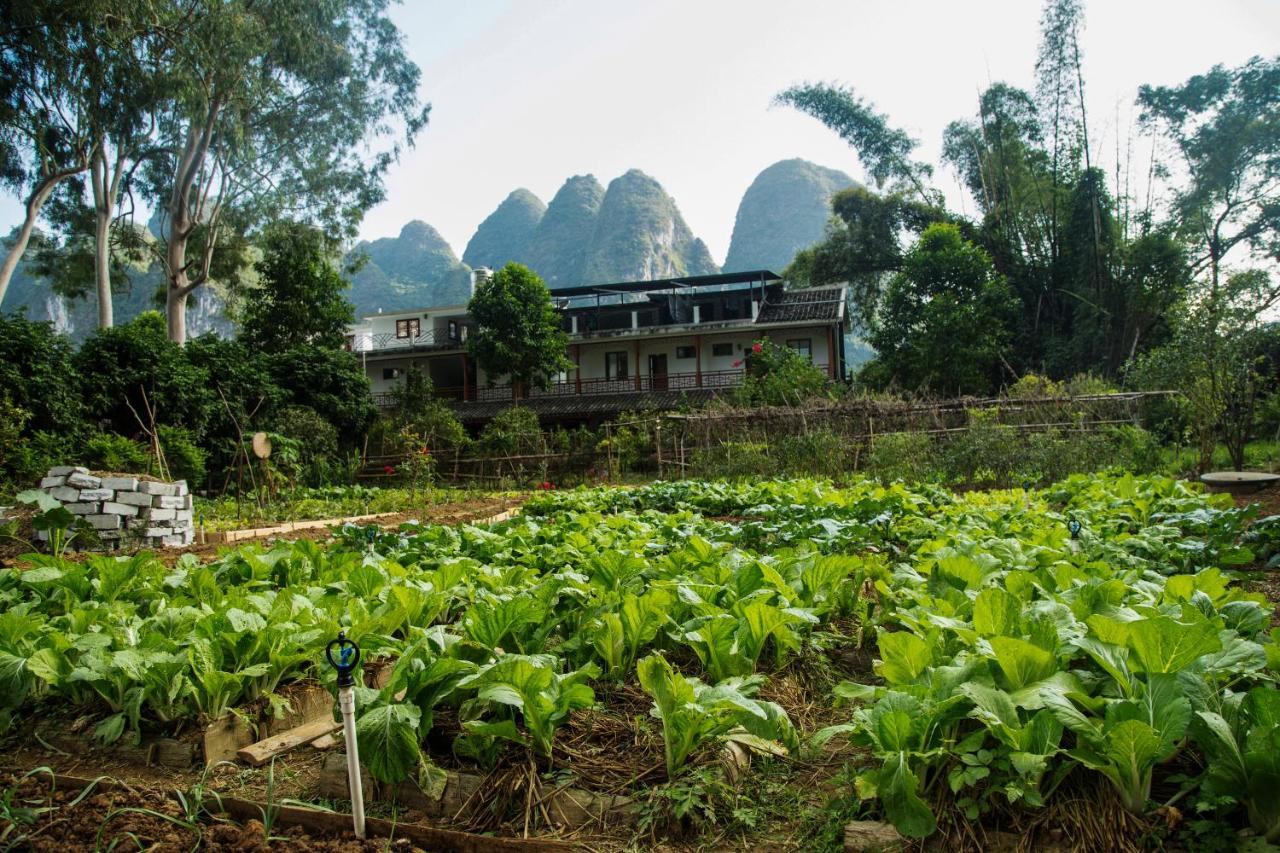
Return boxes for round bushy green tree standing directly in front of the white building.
[467,263,573,388]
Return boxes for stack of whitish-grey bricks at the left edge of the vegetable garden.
[40,466,195,548]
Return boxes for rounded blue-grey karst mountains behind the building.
[3,159,855,327]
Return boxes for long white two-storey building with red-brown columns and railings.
[348,270,845,423]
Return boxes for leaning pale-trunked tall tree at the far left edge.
[0,0,93,300]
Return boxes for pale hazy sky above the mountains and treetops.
[0,0,1280,263]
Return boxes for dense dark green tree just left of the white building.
[239,222,356,352]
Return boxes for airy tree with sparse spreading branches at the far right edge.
[1138,56,1280,311]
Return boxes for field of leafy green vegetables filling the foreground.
[0,475,1280,848]
